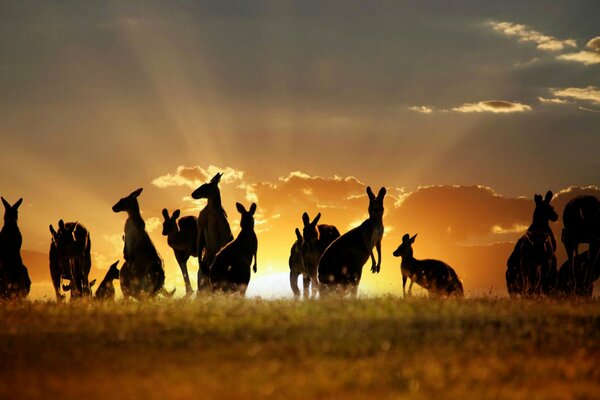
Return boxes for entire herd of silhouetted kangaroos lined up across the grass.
[0,173,600,301]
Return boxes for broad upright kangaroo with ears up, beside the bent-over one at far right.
[506,191,558,297]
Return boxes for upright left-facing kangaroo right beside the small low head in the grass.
[112,188,172,300]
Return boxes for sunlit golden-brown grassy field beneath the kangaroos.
[0,297,600,400]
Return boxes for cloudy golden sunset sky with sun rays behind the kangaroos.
[0,1,600,295]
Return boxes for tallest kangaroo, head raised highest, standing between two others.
[192,173,233,291]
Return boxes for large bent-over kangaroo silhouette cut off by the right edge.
[561,196,600,294]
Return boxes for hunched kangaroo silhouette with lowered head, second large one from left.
[50,219,92,301]
